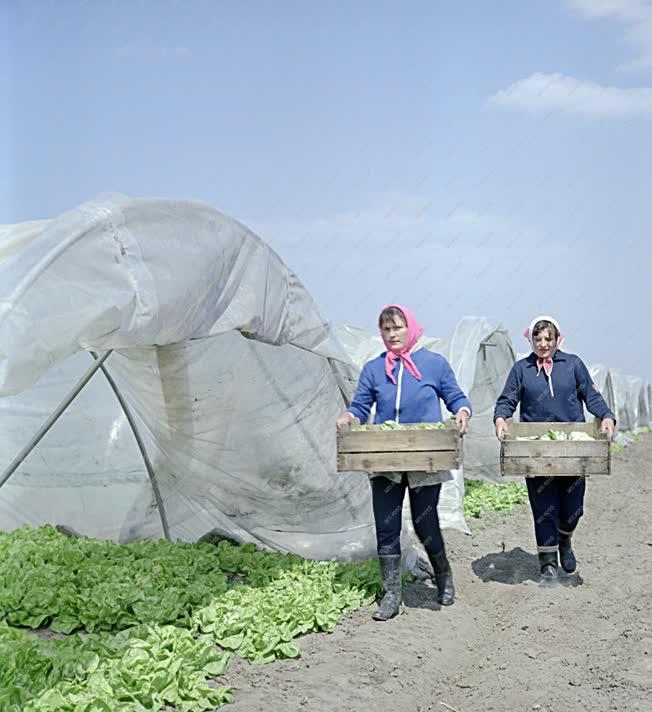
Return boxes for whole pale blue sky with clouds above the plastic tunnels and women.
[0,0,652,379]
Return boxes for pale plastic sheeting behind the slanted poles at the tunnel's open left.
[0,354,149,540]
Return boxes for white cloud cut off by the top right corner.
[566,0,652,71]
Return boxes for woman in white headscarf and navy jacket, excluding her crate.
[494,316,616,580]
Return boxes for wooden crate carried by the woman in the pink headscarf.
[337,421,463,472]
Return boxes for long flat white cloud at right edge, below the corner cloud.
[488,72,652,118]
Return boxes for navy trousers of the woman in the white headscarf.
[525,477,586,552]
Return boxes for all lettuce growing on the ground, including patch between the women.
[0,483,525,712]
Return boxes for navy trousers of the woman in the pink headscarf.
[371,475,444,556]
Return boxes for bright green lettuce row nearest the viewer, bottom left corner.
[0,621,233,712]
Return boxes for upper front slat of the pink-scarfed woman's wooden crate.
[337,428,456,452]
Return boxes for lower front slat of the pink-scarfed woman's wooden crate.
[337,450,461,472]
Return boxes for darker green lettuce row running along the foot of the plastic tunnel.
[0,526,378,633]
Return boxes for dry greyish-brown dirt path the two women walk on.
[222,434,652,712]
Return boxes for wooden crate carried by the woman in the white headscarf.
[500,418,611,477]
